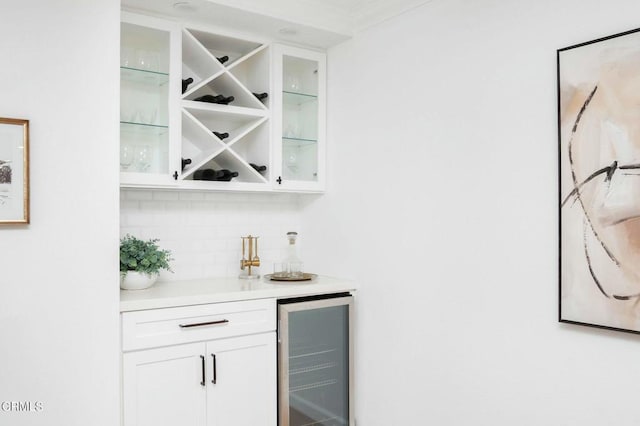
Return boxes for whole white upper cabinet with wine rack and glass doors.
[120,13,326,192]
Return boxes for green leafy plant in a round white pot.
[120,234,173,290]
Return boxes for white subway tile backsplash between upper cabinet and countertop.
[120,189,300,281]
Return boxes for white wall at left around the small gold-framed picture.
[0,0,120,426]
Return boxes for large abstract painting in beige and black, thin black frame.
[557,29,640,333]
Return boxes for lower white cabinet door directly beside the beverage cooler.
[207,332,277,426]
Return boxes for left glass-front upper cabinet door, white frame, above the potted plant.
[120,13,180,186]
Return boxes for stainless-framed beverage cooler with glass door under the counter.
[278,293,354,426]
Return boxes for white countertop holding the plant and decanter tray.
[120,276,356,312]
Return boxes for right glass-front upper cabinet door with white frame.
[273,45,326,191]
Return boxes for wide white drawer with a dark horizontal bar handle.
[122,299,276,351]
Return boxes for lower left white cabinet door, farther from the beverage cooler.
[122,343,206,426]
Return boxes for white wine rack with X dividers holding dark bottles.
[180,25,270,185]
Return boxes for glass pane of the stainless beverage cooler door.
[289,305,349,426]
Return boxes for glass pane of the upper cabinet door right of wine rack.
[282,55,318,181]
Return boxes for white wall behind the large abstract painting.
[302,0,640,426]
